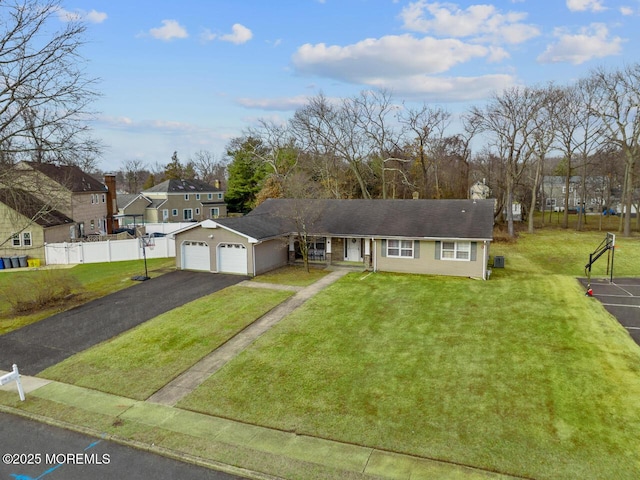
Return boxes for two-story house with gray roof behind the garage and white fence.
[118,179,227,223]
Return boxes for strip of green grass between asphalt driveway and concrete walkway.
[40,286,291,400]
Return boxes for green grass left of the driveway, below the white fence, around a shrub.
[0,258,175,335]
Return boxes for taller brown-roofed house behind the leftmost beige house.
[16,161,112,239]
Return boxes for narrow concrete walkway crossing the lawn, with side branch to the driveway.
[147,270,349,406]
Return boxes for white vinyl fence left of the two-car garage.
[44,236,176,265]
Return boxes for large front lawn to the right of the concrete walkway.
[178,272,640,479]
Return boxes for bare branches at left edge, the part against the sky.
[0,0,100,168]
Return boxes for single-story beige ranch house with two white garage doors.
[175,199,494,279]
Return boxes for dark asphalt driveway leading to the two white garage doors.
[0,270,247,375]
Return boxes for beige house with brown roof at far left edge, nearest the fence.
[0,188,77,264]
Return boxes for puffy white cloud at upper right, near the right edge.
[538,23,623,65]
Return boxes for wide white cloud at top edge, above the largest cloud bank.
[400,0,540,44]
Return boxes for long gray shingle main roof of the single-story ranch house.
[216,199,494,240]
